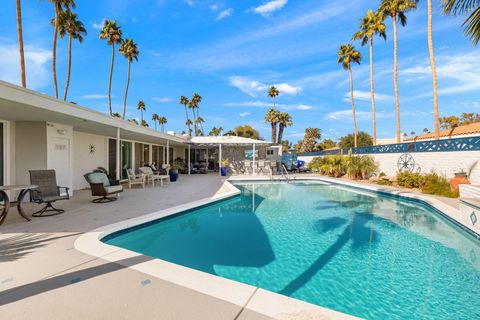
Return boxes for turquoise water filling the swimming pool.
[104,182,480,320]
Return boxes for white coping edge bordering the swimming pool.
[74,176,479,319]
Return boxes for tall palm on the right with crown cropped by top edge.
[378,0,417,143]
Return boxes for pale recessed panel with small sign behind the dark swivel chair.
[48,137,72,194]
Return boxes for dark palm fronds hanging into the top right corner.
[442,0,480,45]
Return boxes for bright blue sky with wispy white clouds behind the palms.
[0,0,480,141]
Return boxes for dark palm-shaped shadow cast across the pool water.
[279,212,378,296]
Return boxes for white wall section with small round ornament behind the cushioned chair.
[73,132,108,190]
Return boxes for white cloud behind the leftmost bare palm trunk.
[0,45,52,90]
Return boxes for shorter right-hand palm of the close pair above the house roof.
[58,9,87,101]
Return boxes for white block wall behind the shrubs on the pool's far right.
[298,151,480,185]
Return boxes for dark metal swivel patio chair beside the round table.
[29,170,70,217]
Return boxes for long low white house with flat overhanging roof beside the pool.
[0,81,282,190]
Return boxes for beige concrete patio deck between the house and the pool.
[0,175,468,320]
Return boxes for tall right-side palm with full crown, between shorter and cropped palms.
[353,10,387,145]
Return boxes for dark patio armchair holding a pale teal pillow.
[83,172,123,203]
